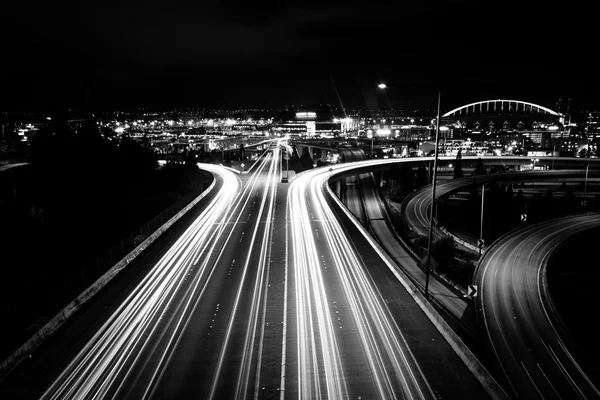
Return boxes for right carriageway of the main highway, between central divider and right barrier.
[285,164,494,399]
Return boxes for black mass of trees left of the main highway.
[0,121,211,356]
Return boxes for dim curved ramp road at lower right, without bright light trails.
[476,213,600,400]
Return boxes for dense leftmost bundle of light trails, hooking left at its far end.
[42,164,240,399]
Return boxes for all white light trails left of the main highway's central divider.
[42,145,279,399]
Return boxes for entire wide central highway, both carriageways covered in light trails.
[0,150,506,399]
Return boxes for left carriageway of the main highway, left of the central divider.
[35,145,283,399]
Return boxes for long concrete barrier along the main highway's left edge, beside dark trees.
[0,179,216,380]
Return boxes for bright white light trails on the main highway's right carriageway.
[288,165,435,399]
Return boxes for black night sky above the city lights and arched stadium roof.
[0,0,600,110]
